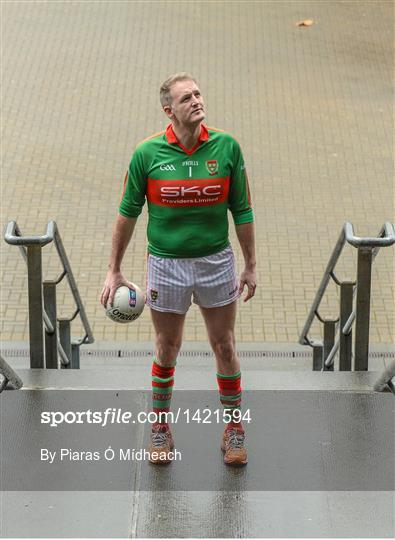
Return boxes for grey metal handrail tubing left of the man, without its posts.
[4,221,94,365]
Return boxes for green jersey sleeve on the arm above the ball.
[119,148,147,217]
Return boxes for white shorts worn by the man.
[146,246,240,314]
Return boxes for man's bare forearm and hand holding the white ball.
[100,214,137,307]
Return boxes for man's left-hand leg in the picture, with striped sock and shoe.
[149,309,185,464]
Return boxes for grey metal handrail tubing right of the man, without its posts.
[299,222,395,348]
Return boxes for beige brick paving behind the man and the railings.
[1,1,394,343]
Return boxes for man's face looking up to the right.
[164,81,206,125]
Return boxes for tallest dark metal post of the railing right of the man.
[354,247,373,371]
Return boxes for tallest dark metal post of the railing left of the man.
[27,244,44,368]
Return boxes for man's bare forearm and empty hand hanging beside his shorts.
[235,222,256,302]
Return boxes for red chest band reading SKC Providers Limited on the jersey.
[147,176,229,207]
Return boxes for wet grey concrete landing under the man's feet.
[0,374,394,538]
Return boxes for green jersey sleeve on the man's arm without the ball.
[229,139,254,225]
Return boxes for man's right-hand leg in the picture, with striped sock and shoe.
[200,301,247,466]
